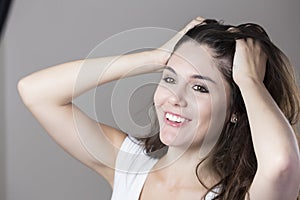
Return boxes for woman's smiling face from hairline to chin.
[154,42,230,152]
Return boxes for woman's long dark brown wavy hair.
[142,20,300,200]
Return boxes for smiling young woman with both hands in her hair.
[18,17,300,200]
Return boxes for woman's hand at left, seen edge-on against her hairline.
[155,16,205,65]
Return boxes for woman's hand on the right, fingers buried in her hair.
[232,38,267,87]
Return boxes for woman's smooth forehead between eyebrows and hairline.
[168,42,222,82]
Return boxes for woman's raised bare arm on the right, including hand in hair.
[233,39,300,200]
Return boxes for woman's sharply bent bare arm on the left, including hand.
[18,18,202,186]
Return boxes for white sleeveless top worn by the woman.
[111,137,219,200]
